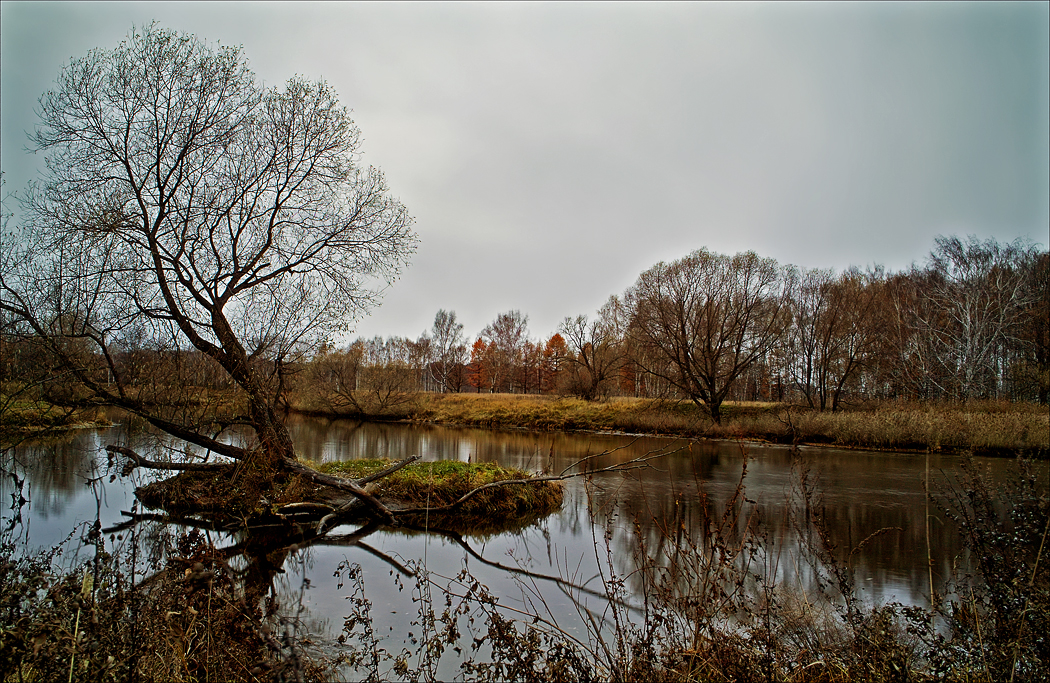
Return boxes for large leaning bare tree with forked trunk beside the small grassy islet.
[0,25,416,510]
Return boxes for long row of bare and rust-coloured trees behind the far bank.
[291,236,1050,420]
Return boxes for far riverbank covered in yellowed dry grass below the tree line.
[293,394,1050,458]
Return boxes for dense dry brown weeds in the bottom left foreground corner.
[0,531,324,683]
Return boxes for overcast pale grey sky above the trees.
[0,1,1050,338]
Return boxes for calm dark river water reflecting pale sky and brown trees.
[6,411,1046,672]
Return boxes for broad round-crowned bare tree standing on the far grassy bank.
[628,249,789,422]
